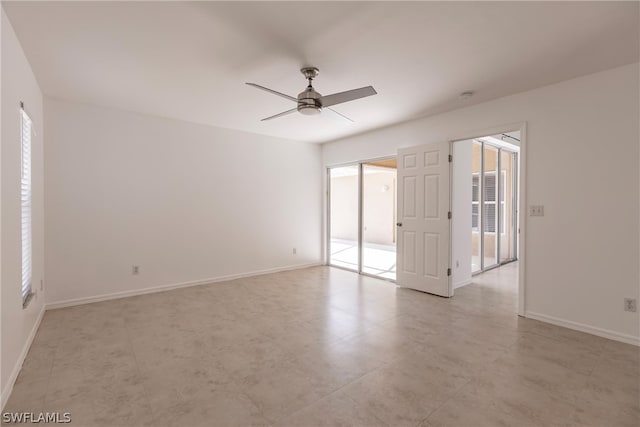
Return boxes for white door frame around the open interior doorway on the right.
[448,122,527,317]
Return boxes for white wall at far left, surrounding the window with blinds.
[0,9,45,407]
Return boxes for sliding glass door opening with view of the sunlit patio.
[327,158,397,281]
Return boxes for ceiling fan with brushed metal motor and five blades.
[247,67,378,122]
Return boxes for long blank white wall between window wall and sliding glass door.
[45,98,322,304]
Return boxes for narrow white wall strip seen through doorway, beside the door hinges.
[451,141,471,288]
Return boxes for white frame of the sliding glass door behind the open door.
[324,154,398,283]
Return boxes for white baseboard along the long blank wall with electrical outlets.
[46,262,322,310]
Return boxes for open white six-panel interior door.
[396,142,453,297]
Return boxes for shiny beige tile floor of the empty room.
[5,264,640,427]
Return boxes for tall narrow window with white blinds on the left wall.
[20,108,33,306]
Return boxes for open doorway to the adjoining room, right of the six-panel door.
[452,131,521,308]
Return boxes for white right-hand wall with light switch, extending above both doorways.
[323,63,640,343]
